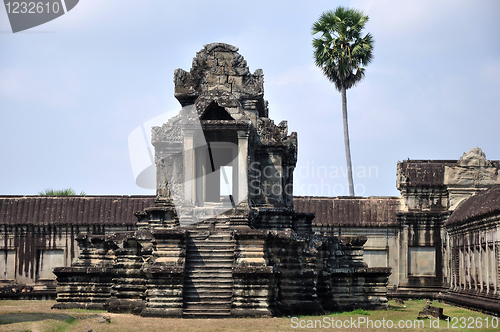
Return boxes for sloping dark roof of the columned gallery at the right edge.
[446,185,500,225]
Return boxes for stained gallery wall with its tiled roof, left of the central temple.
[0,196,153,298]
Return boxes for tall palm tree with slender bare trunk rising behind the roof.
[312,7,373,196]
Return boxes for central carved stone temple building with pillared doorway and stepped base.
[54,43,391,317]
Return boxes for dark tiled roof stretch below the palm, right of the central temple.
[293,196,400,227]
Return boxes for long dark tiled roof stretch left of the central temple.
[0,196,155,225]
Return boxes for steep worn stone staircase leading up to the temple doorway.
[183,229,235,318]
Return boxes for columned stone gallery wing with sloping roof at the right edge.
[441,186,500,314]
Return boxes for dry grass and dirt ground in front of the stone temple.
[0,300,500,332]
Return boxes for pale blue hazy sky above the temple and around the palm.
[0,0,500,196]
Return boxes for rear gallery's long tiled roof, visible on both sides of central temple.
[0,196,399,227]
